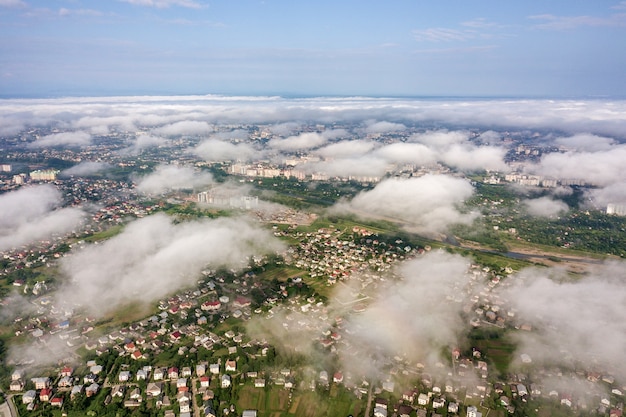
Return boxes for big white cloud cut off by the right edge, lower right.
[504,261,626,380]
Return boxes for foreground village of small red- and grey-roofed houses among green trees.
[2,214,624,417]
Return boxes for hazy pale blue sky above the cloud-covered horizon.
[0,0,626,97]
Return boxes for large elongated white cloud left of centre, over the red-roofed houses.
[57,214,282,316]
